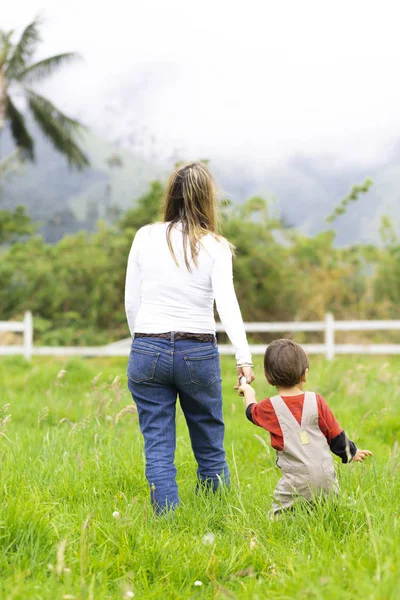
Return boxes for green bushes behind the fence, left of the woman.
[0,229,132,345]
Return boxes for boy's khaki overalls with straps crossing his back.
[271,392,339,515]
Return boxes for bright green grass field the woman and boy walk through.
[0,358,400,600]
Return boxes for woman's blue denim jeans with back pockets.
[128,333,229,512]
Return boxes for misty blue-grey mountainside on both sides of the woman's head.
[0,124,400,245]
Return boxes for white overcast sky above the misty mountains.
[0,0,400,165]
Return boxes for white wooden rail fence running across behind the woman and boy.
[0,312,400,360]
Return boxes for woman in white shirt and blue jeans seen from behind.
[125,163,254,512]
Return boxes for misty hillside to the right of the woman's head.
[215,151,400,245]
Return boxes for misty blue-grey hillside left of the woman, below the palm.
[0,123,167,242]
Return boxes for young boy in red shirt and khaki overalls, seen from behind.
[236,339,372,516]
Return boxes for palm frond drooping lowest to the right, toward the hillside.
[24,88,89,169]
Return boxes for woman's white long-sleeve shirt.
[125,223,251,364]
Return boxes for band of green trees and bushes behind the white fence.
[0,181,400,345]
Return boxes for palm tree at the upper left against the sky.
[0,19,89,169]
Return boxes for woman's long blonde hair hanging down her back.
[164,162,225,271]
